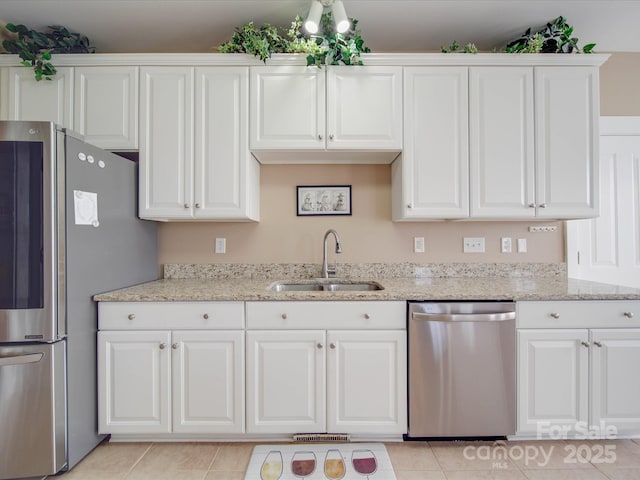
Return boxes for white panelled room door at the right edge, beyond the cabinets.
[567,117,640,288]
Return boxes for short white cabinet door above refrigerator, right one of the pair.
[74,66,138,150]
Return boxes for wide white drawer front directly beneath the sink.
[247,301,407,330]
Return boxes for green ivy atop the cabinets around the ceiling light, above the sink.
[218,12,371,66]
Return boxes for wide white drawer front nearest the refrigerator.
[98,302,244,330]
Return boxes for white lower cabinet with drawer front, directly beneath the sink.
[247,302,407,435]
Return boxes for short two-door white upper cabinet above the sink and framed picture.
[249,66,402,163]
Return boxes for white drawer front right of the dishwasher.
[517,300,640,328]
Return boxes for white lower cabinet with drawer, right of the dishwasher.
[517,301,640,437]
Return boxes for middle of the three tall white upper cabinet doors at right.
[469,67,535,218]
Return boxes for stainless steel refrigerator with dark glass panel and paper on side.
[0,121,157,480]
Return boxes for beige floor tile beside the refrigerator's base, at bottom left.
[65,442,151,472]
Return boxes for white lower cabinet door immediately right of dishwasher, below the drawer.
[517,329,589,436]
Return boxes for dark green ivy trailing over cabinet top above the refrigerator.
[2,23,95,81]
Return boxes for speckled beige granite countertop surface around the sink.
[94,275,640,302]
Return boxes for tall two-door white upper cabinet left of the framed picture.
[140,66,259,220]
